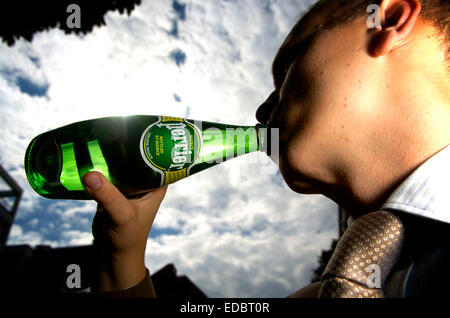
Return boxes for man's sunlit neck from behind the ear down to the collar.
[328,24,450,217]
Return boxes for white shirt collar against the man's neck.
[382,146,450,223]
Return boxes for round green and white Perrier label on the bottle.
[140,116,202,186]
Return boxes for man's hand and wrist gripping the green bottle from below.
[83,172,167,291]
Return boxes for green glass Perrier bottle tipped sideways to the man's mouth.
[25,115,267,200]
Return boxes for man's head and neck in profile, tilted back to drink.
[257,0,450,213]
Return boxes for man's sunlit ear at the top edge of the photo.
[369,0,422,57]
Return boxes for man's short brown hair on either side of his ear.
[310,0,450,61]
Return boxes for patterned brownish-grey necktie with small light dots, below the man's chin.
[318,211,405,298]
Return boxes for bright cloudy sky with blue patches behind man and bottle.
[0,0,337,297]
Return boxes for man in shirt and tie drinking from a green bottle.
[83,0,450,297]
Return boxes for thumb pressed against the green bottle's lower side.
[83,171,133,224]
